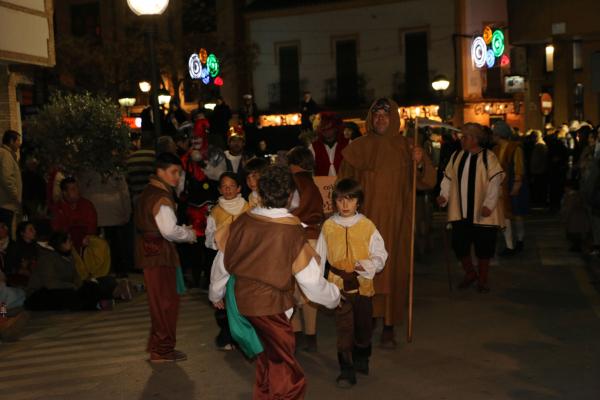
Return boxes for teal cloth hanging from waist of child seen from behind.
[225,275,264,358]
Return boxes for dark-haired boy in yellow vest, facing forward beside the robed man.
[317,179,388,387]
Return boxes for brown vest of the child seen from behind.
[224,213,308,317]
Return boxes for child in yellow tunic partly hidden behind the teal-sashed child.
[205,172,250,351]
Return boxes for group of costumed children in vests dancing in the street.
[137,147,387,399]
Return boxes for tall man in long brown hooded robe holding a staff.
[338,99,436,347]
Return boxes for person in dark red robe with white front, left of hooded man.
[311,112,348,176]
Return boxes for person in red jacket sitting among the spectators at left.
[51,177,98,252]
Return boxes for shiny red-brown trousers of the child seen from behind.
[246,314,306,400]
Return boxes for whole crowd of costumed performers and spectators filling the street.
[0,90,600,399]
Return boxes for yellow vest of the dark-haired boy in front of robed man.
[322,217,376,297]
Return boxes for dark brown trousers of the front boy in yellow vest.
[335,293,373,353]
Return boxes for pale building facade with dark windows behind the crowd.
[246,0,523,128]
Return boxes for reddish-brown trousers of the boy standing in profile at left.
[144,267,179,356]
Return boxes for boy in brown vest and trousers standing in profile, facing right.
[133,153,196,362]
